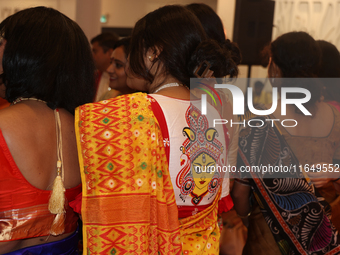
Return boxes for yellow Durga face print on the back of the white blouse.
[176,104,226,205]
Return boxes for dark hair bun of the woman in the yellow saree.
[188,39,238,78]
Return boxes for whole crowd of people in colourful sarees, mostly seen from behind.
[0,4,340,255]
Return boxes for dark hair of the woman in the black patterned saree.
[269,32,322,112]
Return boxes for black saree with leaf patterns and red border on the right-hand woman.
[238,116,340,255]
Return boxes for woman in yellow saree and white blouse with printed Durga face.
[76,5,237,254]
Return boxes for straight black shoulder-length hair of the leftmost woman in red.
[0,7,95,114]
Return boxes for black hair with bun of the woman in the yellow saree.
[129,5,237,86]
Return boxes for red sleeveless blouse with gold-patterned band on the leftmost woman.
[0,130,81,242]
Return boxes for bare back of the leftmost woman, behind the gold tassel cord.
[0,101,81,254]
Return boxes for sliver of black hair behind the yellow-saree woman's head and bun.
[186,3,242,65]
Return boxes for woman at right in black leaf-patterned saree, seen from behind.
[232,32,340,255]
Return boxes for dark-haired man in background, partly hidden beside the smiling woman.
[91,33,118,102]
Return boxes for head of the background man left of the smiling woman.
[91,33,118,72]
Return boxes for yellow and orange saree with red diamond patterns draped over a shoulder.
[75,93,220,254]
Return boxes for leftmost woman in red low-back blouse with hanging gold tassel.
[0,7,94,255]
